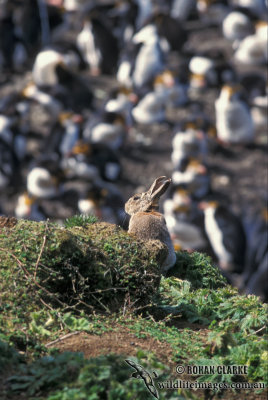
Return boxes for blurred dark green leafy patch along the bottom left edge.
[7,352,184,400]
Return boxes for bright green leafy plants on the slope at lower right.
[155,278,268,382]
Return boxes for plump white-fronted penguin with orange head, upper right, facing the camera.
[215,84,255,144]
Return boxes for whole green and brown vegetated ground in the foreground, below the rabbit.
[0,218,268,400]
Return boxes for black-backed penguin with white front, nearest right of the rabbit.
[199,200,246,273]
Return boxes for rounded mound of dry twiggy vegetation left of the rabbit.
[0,220,165,318]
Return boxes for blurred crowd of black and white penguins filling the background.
[0,0,268,300]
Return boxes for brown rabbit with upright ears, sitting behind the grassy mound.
[125,176,176,273]
